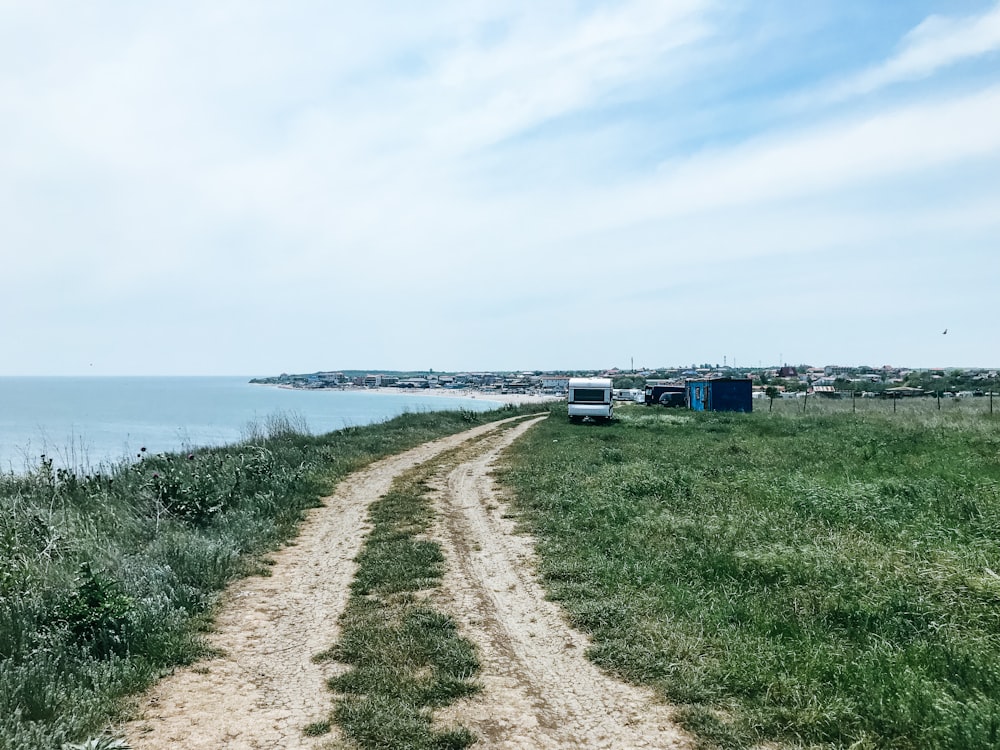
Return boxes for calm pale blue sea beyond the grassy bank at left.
[0,377,497,471]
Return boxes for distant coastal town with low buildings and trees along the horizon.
[250,364,1000,398]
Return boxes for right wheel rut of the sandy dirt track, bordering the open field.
[435,423,691,750]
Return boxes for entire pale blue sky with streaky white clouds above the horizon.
[0,0,1000,375]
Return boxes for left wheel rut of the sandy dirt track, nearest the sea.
[123,422,528,750]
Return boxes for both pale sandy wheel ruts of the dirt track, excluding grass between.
[124,420,687,750]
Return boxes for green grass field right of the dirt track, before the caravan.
[502,400,1000,748]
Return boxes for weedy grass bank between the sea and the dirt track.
[0,407,537,750]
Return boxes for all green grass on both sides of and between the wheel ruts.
[0,398,1000,750]
